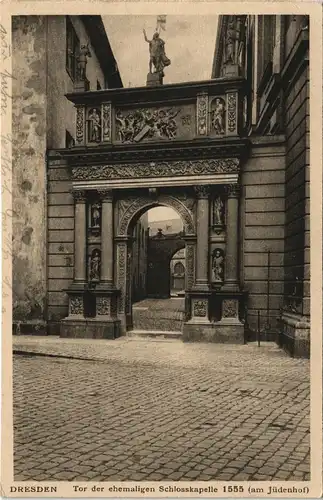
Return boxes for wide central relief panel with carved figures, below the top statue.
[115,105,195,143]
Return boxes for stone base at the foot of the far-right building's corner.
[277,312,311,358]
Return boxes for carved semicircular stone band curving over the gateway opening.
[118,195,195,236]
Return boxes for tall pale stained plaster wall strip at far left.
[12,16,47,333]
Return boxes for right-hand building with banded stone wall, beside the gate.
[212,15,310,356]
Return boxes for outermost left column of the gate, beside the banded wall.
[73,191,86,284]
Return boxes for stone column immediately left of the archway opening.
[99,191,114,288]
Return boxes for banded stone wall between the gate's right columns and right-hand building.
[240,136,285,331]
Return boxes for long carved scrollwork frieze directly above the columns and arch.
[72,158,239,180]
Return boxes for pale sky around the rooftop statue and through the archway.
[103,16,218,221]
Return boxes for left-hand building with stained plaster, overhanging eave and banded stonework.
[12,16,122,333]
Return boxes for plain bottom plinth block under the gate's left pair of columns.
[60,317,121,339]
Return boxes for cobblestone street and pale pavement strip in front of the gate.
[14,336,310,481]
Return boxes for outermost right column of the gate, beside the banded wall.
[223,184,240,291]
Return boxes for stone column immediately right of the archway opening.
[195,186,209,290]
